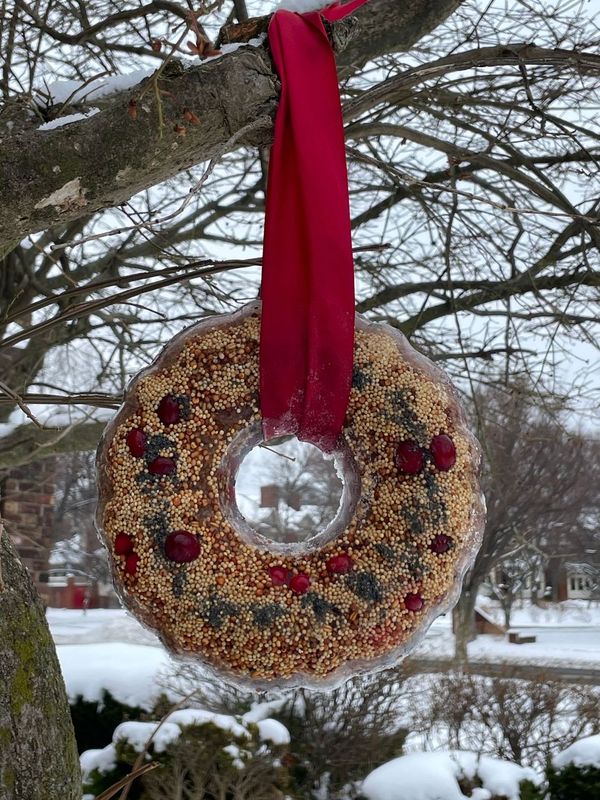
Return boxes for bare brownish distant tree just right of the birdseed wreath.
[454,382,600,660]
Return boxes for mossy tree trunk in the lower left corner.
[0,524,81,800]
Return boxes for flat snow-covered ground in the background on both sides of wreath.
[47,601,600,706]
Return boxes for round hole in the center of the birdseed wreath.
[235,436,344,544]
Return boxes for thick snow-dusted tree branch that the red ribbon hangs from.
[0,0,463,247]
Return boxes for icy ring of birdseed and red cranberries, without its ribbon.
[98,304,484,687]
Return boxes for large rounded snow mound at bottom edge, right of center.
[361,750,542,800]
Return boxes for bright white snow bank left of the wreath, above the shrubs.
[56,642,175,710]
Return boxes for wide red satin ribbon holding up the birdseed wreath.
[260,0,367,451]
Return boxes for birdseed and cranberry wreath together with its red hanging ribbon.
[97,0,484,688]
